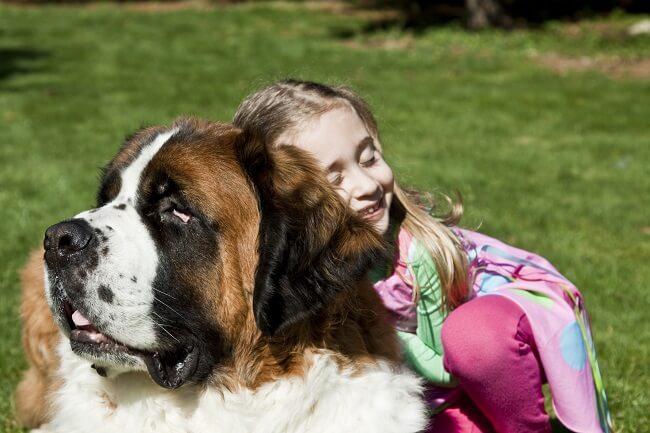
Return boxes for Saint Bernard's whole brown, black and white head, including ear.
[44,119,382,388]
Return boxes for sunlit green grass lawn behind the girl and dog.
[0,5,650,432]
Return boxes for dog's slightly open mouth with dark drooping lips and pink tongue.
[62,300,199,389]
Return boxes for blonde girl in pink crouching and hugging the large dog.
[234,80,611,433]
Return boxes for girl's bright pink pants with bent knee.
[429,295,551,433]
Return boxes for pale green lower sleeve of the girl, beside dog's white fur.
[397,331,456,387]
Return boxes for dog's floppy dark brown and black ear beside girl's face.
[238,132,386,335]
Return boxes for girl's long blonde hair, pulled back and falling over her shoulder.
[233,80,469,309]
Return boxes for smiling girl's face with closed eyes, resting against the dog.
[279,107,394,234]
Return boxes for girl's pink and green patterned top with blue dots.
[375,229,611,433]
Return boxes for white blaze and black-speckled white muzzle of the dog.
[68,129,177,350]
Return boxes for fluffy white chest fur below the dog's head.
[38,340,426,433]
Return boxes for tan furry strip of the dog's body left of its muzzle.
[15,249,59,428]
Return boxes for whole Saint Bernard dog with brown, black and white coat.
[15,119,427,433]
